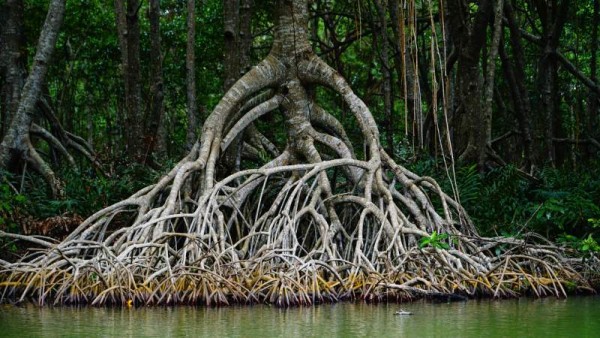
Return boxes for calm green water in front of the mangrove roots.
[0,297,600,338]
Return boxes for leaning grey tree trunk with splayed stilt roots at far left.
[0,0,103,198]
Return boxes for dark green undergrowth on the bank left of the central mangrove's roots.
[0,163,171,242]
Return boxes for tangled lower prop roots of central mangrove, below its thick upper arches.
[0,159,589,306]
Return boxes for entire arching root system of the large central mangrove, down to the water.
[0,1,587,305]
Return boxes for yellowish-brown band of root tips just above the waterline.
[0,256,573,307]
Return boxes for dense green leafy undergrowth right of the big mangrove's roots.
[411,158,600,257]
